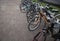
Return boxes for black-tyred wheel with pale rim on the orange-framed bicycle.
[28,11,41,31]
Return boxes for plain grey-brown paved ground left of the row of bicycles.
[0,0,38,41]
